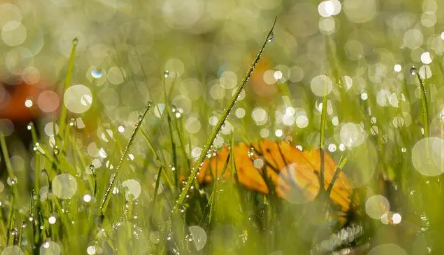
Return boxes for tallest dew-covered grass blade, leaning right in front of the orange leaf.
[174,17,277,212]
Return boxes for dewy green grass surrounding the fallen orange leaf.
[0,3,444,255]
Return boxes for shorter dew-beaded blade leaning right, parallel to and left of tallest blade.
[100,102,151,217]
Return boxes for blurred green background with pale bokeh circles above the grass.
[0,0,444,139]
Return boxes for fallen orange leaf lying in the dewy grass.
[198,139,353,211]
